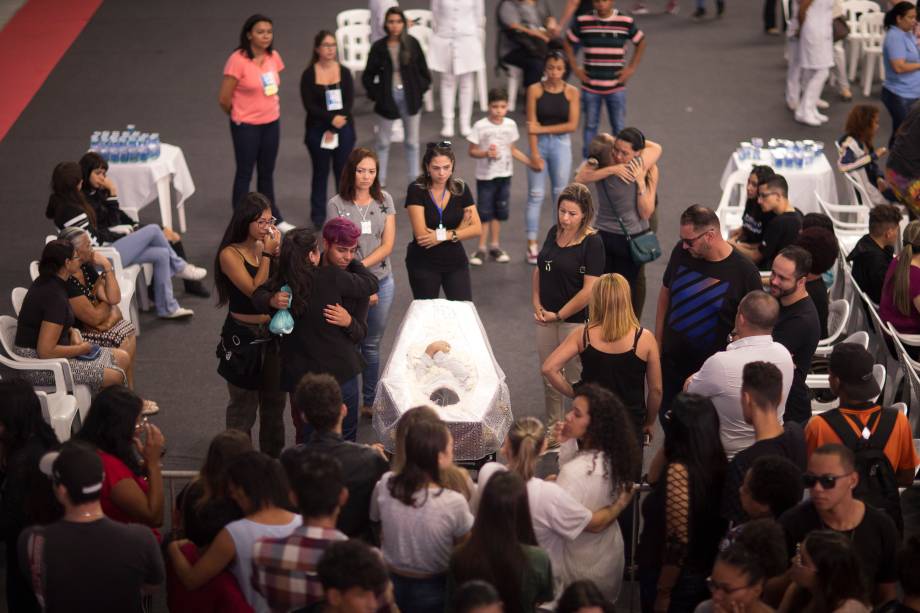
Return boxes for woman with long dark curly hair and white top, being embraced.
[555,383,642,601]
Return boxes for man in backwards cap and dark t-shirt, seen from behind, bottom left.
[19,442,164,613]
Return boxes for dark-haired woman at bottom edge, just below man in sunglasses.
[779,530,872,613]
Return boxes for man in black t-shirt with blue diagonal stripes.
[655,205,761,415]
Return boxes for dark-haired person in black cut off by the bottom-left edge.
[0,378,62,613]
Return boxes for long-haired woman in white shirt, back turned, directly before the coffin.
[370,419,473,613]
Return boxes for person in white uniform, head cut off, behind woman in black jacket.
[428,0,485,138]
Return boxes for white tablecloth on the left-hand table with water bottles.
[109,143,195,232]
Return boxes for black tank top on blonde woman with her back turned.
[581,324,647,432]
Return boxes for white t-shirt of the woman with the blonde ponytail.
[470,462,594,587]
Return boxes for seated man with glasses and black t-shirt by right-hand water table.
[737,175,802,270]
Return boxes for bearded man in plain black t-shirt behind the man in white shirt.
[770,245,821,424]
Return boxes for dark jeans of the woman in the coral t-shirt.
[230,120,282,221]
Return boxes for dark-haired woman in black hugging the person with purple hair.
[252,228,378,443]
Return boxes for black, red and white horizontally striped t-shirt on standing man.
[567,10,645,94]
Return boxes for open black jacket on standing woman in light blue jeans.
[361,36,431,119]
